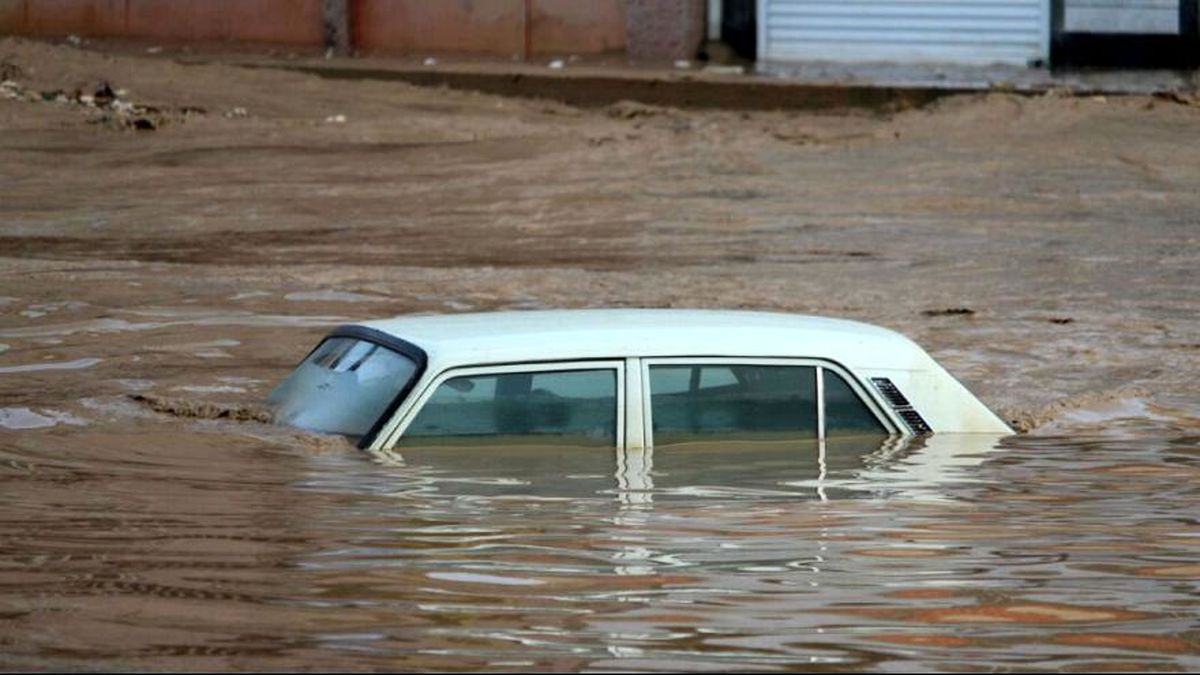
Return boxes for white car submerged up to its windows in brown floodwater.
[269,310,1010,450]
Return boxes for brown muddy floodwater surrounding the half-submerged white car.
[0,38,1200,671]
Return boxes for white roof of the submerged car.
[359,309,929,370]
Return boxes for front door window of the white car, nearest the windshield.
[401,369,617,447]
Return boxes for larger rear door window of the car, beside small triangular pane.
[649,365,817,446]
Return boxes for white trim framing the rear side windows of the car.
[638,357,904,448]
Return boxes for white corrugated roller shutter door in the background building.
[758,0,1050,66]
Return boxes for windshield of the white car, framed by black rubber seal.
[266,338,416,440]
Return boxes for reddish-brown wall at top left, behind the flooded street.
[0,0,704,59]
